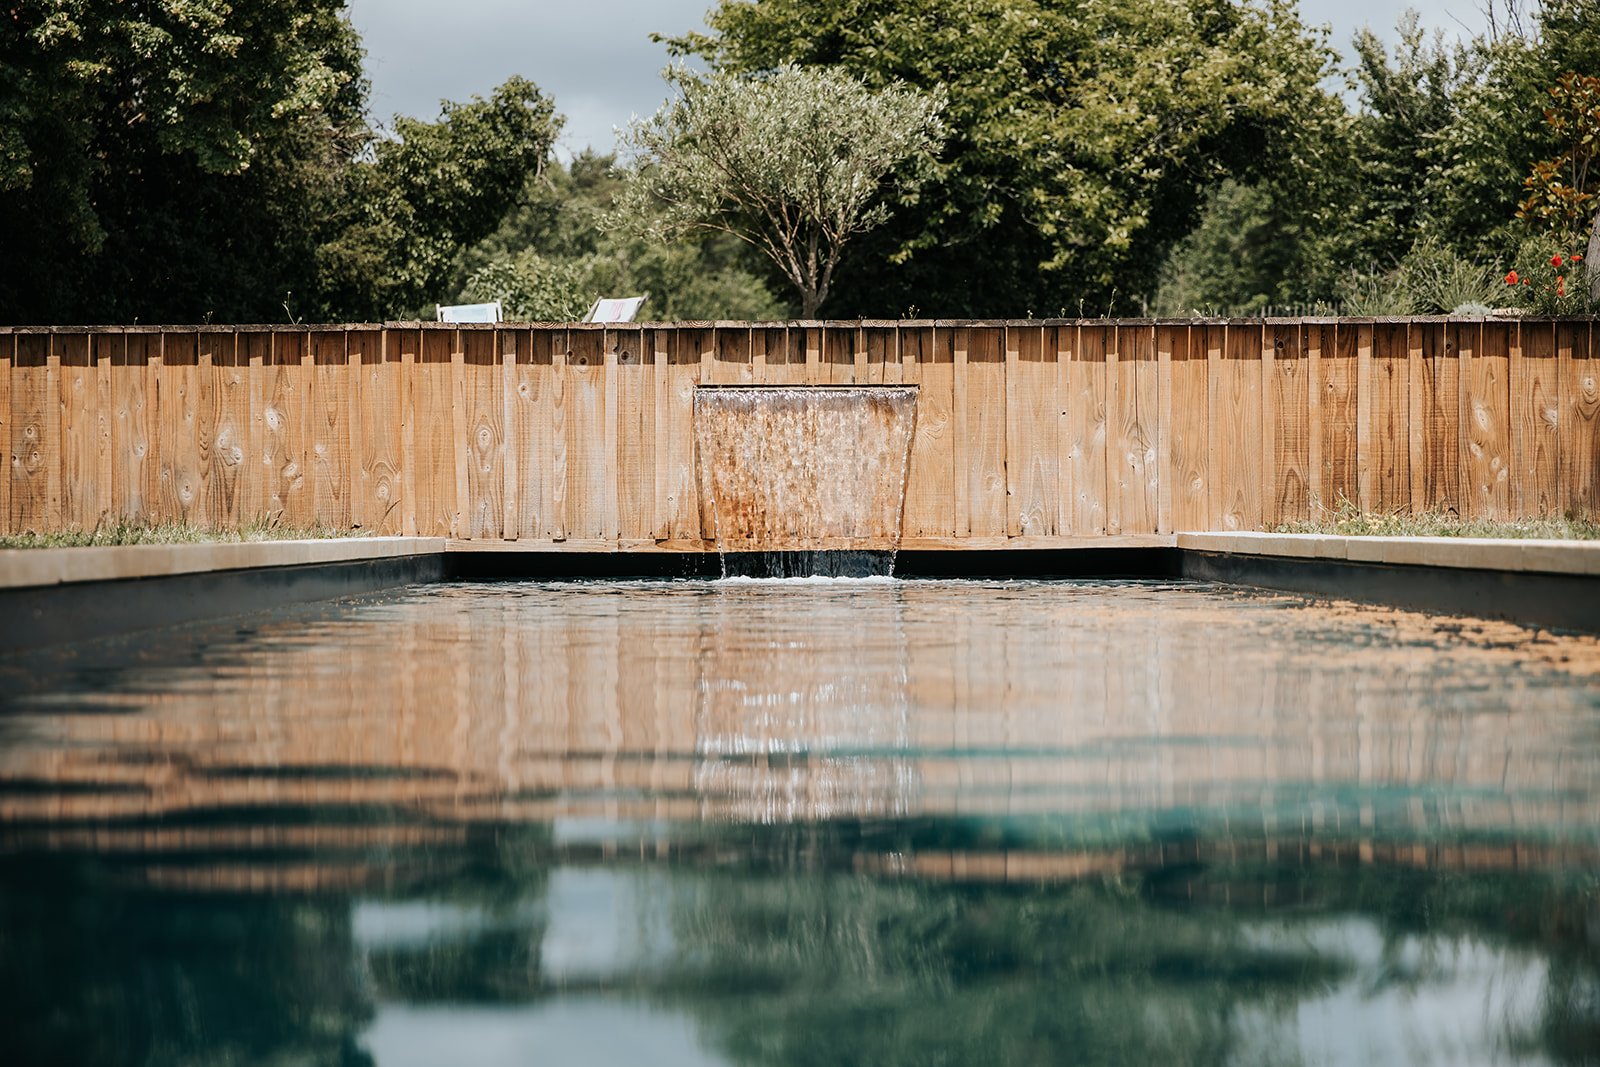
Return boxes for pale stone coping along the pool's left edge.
[0,537,445,589]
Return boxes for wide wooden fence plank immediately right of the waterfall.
[901,325,955,537]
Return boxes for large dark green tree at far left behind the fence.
[0,0,365,322]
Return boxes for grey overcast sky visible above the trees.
[350,0,1486,157]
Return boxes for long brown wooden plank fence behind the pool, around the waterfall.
[0,318,1600,550]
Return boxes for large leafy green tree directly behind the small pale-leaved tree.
[669,0,1347,315]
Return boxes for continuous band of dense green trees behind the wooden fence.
[9,0,1600,323]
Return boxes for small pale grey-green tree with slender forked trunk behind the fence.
[608,64,944,318]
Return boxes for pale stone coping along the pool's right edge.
[1178,533,1600,576]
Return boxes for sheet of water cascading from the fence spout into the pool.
[694,386,917,577]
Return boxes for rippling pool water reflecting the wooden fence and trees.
[0,579,1600,1067]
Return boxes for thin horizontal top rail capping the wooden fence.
[0,315,1600,336]
